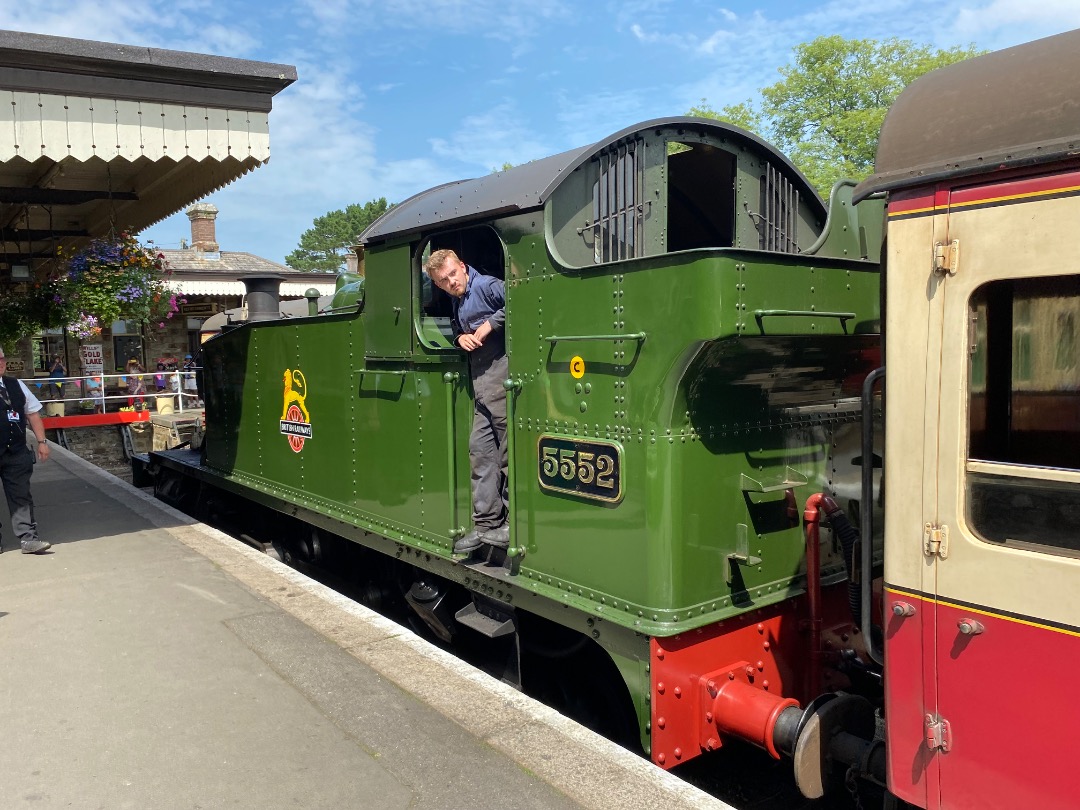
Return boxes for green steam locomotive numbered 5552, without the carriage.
[152,118,883,790]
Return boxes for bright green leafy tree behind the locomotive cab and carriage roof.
[688,36,982,195]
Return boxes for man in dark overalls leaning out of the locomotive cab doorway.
[426,249,510,556]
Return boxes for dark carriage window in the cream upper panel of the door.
[968,276,1080,552]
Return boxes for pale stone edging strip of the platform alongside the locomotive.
[46,446,734,810]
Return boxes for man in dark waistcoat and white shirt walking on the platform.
[0,349,51,554]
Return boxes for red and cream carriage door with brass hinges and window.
[924,173,1080,810]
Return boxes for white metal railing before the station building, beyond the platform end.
[23,368,200,416]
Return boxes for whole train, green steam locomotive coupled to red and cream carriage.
[151,27,1080,808]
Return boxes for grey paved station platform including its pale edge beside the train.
[0,447,728,810]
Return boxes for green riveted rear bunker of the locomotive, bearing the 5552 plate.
[509,244,878,635]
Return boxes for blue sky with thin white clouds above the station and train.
[0,0,1080,261]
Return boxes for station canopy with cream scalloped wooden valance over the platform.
[0,30,296,270]
